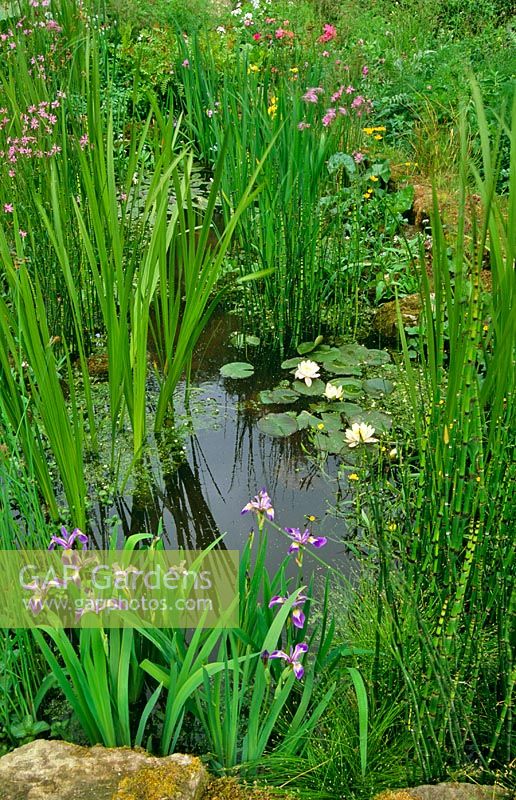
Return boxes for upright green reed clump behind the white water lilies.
[178,34,366,352]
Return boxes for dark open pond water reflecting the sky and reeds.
[93,315,351,573]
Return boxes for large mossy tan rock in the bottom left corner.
[0,739,208,800]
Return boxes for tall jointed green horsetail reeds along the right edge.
[364,84,516,778]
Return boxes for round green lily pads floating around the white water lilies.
[221,337,394,455]
